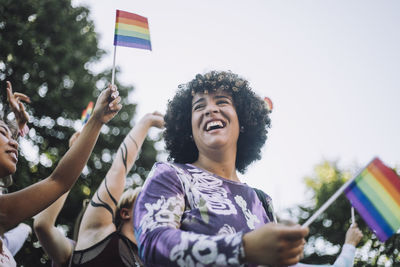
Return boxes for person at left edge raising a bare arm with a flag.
[0,83,122,266]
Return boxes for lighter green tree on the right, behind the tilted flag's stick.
[290,161,400,266]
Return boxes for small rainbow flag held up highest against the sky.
[114,10,151,50]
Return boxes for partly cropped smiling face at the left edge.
[0,120,18,177]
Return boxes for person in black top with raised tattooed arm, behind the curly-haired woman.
[34,112,164,267]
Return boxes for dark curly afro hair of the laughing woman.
[164,71,271,173]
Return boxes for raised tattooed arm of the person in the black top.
[76,112,164,249]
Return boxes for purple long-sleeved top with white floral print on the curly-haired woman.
[134,163,274,267]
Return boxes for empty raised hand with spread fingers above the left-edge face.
[7,81,31,130]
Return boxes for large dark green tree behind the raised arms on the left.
[0,0,157,266]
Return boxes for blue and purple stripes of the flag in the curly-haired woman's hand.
[345,184,393,242]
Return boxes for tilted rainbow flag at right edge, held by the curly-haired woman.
[344,158,400,242]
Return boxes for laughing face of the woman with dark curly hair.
[192,91,239,157]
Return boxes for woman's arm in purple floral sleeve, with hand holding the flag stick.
[134,163,308,266]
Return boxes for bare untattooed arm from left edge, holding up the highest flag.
[0,86,122,233]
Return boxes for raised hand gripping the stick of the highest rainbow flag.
[89,85,122,123]
